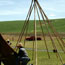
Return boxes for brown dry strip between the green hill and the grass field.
[2,33,65,41]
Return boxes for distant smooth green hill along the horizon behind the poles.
[0,19,65,33]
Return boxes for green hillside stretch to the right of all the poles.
[52,19,65,32]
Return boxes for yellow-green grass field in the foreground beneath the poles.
[12,38,65,65]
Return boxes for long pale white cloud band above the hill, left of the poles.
[0,9,27,16]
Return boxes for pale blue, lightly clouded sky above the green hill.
[0,0,65,21]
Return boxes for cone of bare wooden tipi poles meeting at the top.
[17,0,65,65]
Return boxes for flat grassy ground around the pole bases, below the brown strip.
[3,36,65,65]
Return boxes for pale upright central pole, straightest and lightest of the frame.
[34,0,37,65]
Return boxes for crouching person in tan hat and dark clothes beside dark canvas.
[17,43,30,65]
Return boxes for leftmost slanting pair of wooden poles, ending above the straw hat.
[16,0,33,45]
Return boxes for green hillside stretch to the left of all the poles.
[0,21,24,33]
